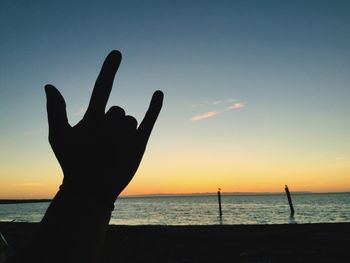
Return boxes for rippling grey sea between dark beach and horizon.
[0,193,350,225]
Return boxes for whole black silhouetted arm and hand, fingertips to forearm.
[7,51,163,262]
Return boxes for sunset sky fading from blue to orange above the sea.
[0,0,350,198]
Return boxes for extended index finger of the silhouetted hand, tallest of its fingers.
[85,50,122,117]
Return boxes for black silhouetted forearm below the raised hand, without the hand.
[8,190,111,262]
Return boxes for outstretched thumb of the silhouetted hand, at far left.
[45,84,68,135]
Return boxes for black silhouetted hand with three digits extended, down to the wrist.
[45,51,163,209]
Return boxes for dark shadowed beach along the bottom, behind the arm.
[0,222,350,263]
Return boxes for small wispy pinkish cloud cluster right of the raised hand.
[190,99,245,121]
